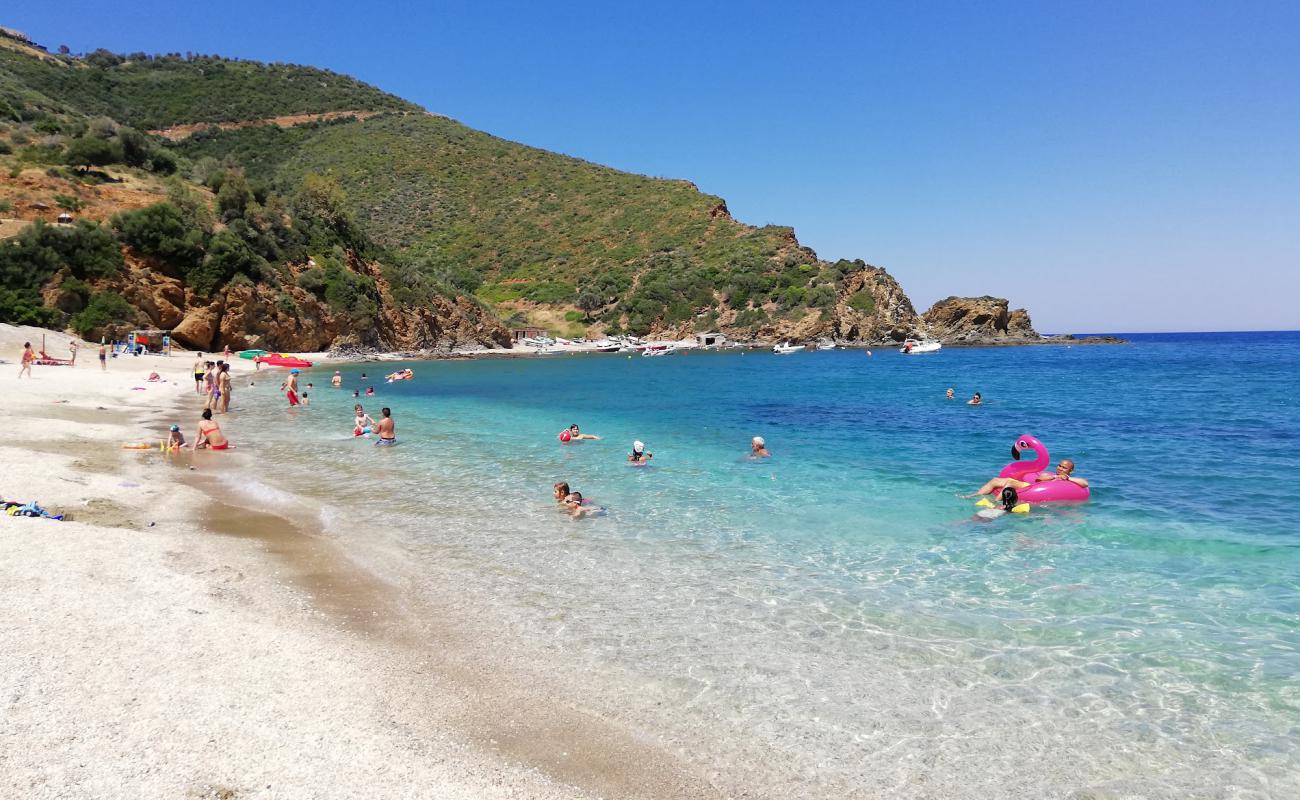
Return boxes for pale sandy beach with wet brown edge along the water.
[0,325,722,797]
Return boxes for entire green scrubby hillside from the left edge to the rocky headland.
[0,29,911,336]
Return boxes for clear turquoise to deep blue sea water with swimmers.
[218,333,1300,797]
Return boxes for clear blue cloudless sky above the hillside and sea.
[12,0,1300,332]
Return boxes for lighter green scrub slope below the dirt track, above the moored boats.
[178,114,863,332]
